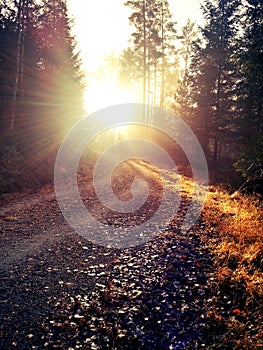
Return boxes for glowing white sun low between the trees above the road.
[84,77,137,113]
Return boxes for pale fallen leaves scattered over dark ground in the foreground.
[34,223,219,349]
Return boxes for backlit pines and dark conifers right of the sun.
[124,0,263,191]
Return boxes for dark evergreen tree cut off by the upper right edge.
[237,0,263,140]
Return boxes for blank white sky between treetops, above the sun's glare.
[68,0,201,71]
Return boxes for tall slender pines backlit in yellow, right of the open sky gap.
[123,0,178,107]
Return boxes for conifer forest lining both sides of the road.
[0,1,263,192]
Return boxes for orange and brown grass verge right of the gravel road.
[200,187,263,349]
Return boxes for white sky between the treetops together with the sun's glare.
[67,0,204,112]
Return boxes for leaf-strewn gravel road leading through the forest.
[0,162,213,350]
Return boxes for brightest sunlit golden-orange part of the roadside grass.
[204,188,263,273]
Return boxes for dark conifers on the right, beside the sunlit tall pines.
[173,0,263,193]
